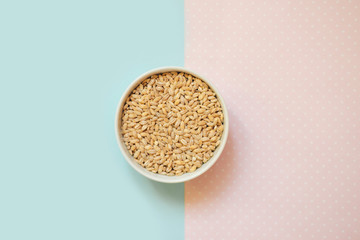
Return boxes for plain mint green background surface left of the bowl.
[0,0,184,240]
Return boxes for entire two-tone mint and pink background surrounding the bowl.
[0,0,360,240]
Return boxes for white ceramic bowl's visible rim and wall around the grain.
[115,67,229,183]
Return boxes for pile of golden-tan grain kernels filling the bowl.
[121,72,224,176]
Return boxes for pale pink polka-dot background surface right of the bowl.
[185,0,360,240]
